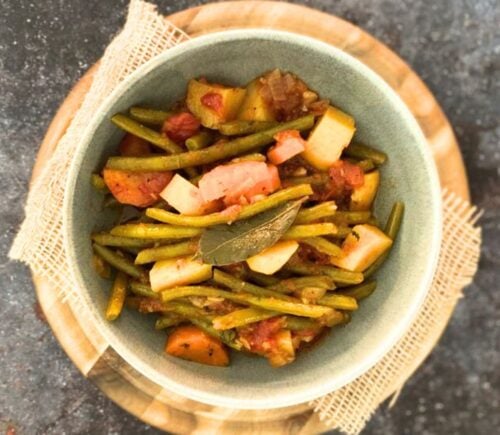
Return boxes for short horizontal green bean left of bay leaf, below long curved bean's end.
[111,223,203,240]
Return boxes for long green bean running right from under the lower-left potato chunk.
[161,286,331,318]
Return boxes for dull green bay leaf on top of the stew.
[198,201,302,266]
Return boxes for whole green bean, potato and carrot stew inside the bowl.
[90,70,404,367]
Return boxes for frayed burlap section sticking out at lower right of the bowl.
[311,192,481,434]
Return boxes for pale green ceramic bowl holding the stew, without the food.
[64,30,441,409]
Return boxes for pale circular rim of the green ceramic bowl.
[62,29,442,410]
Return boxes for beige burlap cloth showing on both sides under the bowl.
[10,0,481,434]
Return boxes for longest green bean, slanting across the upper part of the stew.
[106,115,314,171]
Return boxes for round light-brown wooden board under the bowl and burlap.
[32,1,469,434]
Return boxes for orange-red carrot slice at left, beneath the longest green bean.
[102,168,172,207]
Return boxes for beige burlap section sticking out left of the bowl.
[9,0,189,299]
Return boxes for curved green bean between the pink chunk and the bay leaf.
[146,184,314,228]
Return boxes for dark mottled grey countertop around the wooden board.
[0,0,500,435]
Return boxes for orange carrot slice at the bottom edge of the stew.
[165,325,229,367]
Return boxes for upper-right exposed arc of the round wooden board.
[168,1,469,200]
